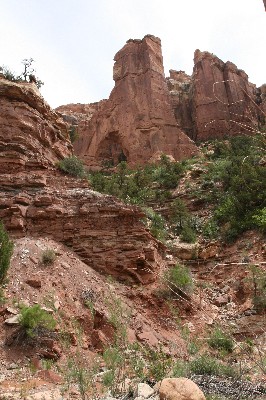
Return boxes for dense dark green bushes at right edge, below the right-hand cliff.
[202,135,266,242]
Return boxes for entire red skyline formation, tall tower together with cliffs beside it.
[57,35,266,158]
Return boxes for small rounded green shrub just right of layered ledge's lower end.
[164,264,193,294]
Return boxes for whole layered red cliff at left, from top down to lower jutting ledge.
[0,79,164,283]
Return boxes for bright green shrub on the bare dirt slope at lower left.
[19,304,56,338]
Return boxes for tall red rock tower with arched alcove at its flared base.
[59,35,197,166]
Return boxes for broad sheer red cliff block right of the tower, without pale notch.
[191,50,261,140]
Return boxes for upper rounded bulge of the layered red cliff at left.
[0,76,72,173]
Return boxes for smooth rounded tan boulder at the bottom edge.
[159,378,205,400]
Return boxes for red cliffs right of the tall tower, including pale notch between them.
[167,50,266,140]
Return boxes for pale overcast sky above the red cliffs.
[0,0,266,107]
